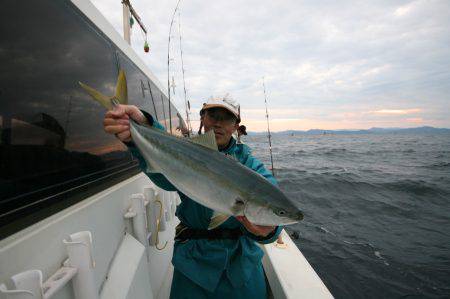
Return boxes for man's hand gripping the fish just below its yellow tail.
[103,105,147,142]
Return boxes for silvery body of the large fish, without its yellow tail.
[131,122,303,228]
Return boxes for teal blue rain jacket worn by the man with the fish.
[128,113,282,299]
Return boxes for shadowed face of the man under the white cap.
[203,108,239,149]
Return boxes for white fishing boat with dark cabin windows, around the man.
[0,0,332,299]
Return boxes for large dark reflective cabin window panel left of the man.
[0,0,180,239]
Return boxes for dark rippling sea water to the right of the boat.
[244,133,450,298]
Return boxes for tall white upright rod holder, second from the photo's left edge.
[63,231,98,299]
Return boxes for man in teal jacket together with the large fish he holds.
[80,73,303,299]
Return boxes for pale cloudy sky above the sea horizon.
[92,0,450,131]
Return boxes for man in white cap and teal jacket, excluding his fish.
[104,98,282,299]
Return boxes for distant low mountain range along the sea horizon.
[248,126,450,135]
